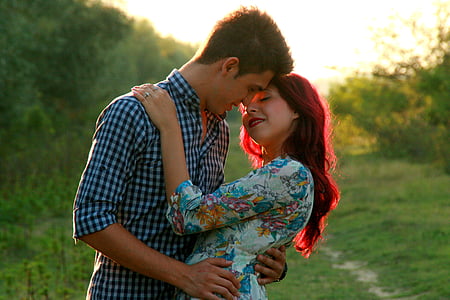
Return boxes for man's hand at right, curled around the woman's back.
[255,246,286,285]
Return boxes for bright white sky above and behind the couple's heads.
[119,0,434,80]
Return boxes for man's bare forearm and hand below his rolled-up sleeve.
[79,223,239,300]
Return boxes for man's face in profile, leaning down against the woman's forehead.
[206,71,273,115]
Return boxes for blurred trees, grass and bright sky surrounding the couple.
[0,0,450,299]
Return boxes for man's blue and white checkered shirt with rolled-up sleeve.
[74,70,229,300]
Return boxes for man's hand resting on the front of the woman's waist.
[177,258,240,300]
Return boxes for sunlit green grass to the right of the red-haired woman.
[269,155,450,300]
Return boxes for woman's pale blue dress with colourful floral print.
[167,157,314,300]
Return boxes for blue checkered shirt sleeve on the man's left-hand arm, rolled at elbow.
[73,97,149,238]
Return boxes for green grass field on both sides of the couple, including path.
[0,146,450,300]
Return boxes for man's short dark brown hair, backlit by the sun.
[195,7,293,76]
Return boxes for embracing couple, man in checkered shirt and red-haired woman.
[74,7,339,299]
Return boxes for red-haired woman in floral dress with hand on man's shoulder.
[133,74,339,299]
